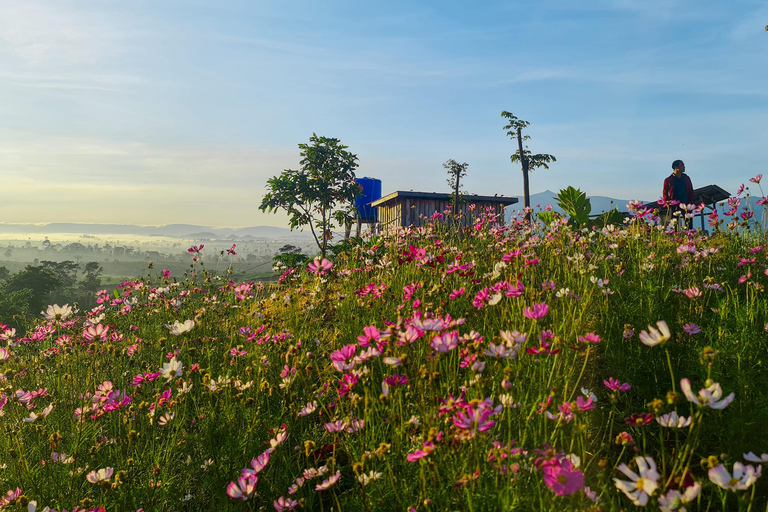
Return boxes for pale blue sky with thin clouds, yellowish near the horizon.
[0,0,768,227]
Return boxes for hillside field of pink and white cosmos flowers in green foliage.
[0,191,768,512]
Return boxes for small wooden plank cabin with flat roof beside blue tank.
[371,190,518,230]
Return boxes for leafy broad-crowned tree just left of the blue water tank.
[259,133,361,258]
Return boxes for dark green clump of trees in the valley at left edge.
[0,260,104,329]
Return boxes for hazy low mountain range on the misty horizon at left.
[0,222,310,239]
